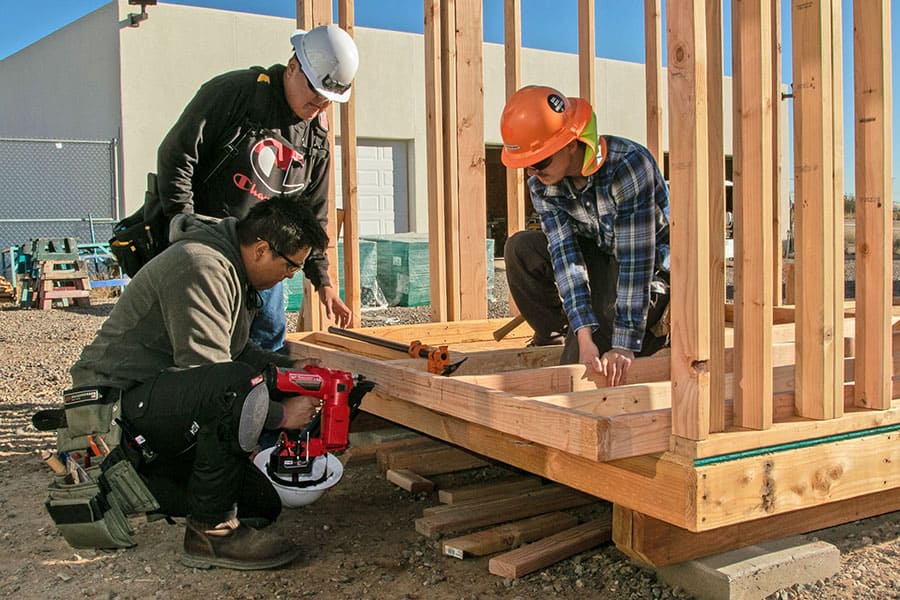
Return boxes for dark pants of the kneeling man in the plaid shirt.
[503,231,669,364]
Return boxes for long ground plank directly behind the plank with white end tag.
[416,486,596,539]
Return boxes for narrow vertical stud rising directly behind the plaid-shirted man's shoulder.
[644,0,665,163]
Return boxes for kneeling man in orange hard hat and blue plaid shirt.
[500,86,669,385]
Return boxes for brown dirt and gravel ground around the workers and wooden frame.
[0,258,900,600]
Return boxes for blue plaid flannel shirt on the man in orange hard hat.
[528,136,669,352]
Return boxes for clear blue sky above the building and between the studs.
[0,0,900,204]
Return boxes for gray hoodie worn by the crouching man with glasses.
[71,215,293,394]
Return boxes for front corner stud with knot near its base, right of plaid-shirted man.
[666,0,713,440]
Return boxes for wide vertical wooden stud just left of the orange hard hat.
[454,0,493,320]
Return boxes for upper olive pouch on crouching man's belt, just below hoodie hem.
[56,386,122,452]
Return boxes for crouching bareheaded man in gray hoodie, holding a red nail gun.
[67,197,356,569]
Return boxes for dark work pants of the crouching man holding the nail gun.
[122,362,281,523]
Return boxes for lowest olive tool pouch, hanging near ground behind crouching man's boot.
[45,467,135,548]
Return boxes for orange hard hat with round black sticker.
[500,85,593,169]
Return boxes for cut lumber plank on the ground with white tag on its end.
[441,512,578,559]
